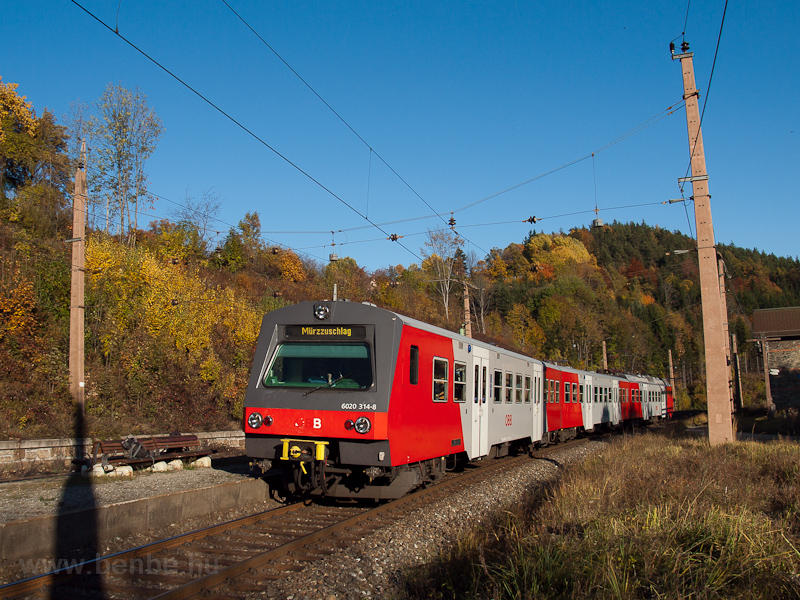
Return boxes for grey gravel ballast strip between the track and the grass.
[251,441,605,600]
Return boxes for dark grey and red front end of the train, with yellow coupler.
[244,301,406,498]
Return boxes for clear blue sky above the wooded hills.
[0,0,800,270]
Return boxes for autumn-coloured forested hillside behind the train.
[0,81,800,438]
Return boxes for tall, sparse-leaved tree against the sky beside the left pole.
[89,83,164,245]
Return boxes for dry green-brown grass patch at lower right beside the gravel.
[404,435,800,600]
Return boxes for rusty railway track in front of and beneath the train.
[0,440,584,600]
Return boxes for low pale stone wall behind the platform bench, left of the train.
[0,431,244,471]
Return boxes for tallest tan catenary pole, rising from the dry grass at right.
[670,42,735,445]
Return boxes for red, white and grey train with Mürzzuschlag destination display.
[244,301,673,498]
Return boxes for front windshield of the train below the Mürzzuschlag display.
[264,342,372,390]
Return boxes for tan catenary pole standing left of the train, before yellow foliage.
[67,141,86,416]
